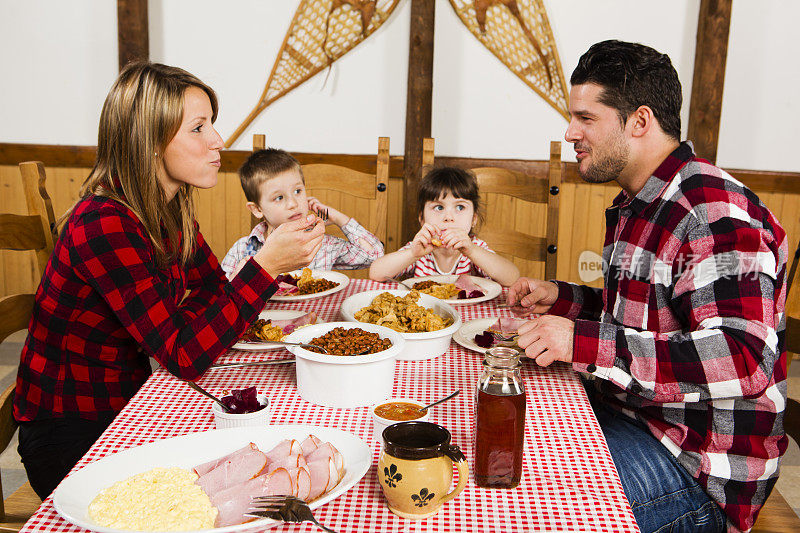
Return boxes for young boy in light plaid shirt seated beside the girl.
[221,148,383,278]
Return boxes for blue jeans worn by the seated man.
[589,392,725,533]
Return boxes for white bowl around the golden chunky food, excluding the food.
[341,289,461,361]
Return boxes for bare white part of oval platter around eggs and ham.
[53,424,372,533]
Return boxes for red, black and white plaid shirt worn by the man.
[551,143,788,530]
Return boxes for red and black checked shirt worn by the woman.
[14,196,277,422]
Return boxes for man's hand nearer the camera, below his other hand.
[517,315,575,366]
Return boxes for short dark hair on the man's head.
[569,40,683,141]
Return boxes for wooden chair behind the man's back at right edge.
[753,243,800,533]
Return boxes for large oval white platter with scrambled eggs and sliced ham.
[53,425,372,533]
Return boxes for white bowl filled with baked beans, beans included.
[284,322,405,408]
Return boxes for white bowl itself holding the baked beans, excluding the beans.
[284,322,405,408]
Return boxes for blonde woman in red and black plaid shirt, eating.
[14,63,324,499]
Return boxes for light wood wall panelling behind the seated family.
[0,160,800,296]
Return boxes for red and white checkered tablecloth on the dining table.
[21,280,638,533]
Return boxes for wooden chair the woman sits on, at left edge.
[0,162,55,531]
